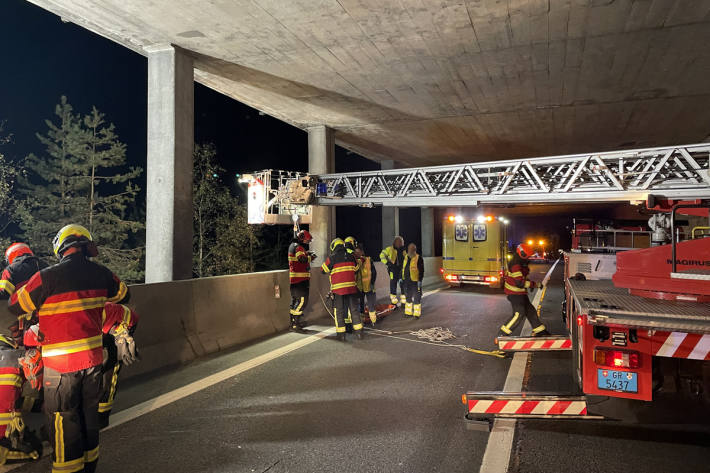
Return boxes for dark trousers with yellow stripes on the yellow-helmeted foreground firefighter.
[44,366,102,473]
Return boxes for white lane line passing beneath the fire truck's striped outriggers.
[479,259,560,473]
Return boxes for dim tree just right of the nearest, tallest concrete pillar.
[192,144,257,277]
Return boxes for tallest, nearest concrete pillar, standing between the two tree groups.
[145,44,194,283]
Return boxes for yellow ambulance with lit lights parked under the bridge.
[441,215,509,288]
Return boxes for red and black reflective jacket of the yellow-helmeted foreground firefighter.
[10,253,128,373]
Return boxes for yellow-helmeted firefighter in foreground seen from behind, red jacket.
[9,224,129,473]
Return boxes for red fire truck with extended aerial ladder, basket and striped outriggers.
[246,144,710,421]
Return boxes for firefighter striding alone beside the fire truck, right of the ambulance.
[500,243,550,337]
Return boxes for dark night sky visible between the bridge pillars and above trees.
[0,0,652,254]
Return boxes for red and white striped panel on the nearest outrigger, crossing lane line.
[468,399,587,416]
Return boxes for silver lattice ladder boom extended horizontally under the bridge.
[316,143,710,206]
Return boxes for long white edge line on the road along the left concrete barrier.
[104,328,335,430]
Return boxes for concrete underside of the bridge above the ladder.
[25,0,710,165]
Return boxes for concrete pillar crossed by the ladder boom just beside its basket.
[308,125,335,264]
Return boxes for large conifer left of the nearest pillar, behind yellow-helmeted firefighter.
[19,97,144,282]
